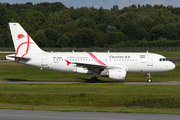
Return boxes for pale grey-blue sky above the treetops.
[0,0,180,9]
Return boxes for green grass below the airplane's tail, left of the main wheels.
[0,62,95,81]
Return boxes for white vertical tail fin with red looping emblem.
[9,22,44,57]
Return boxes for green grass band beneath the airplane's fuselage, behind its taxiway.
[0,62,180,81]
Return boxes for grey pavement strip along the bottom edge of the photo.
[0,109,180,120]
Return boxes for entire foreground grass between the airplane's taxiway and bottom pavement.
[0,84,180,114]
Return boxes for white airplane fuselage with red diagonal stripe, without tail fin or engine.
[8,52,175,73]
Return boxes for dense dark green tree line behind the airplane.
[0,2,180,47]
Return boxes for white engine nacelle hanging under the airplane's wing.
[101,69,127,80]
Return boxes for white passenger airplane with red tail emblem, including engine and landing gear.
[6,22,175,83]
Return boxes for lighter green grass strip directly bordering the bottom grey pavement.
[0,103,180,114]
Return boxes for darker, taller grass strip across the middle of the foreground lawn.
[0,94,180,108]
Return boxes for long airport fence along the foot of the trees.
[0,46,180,52]
